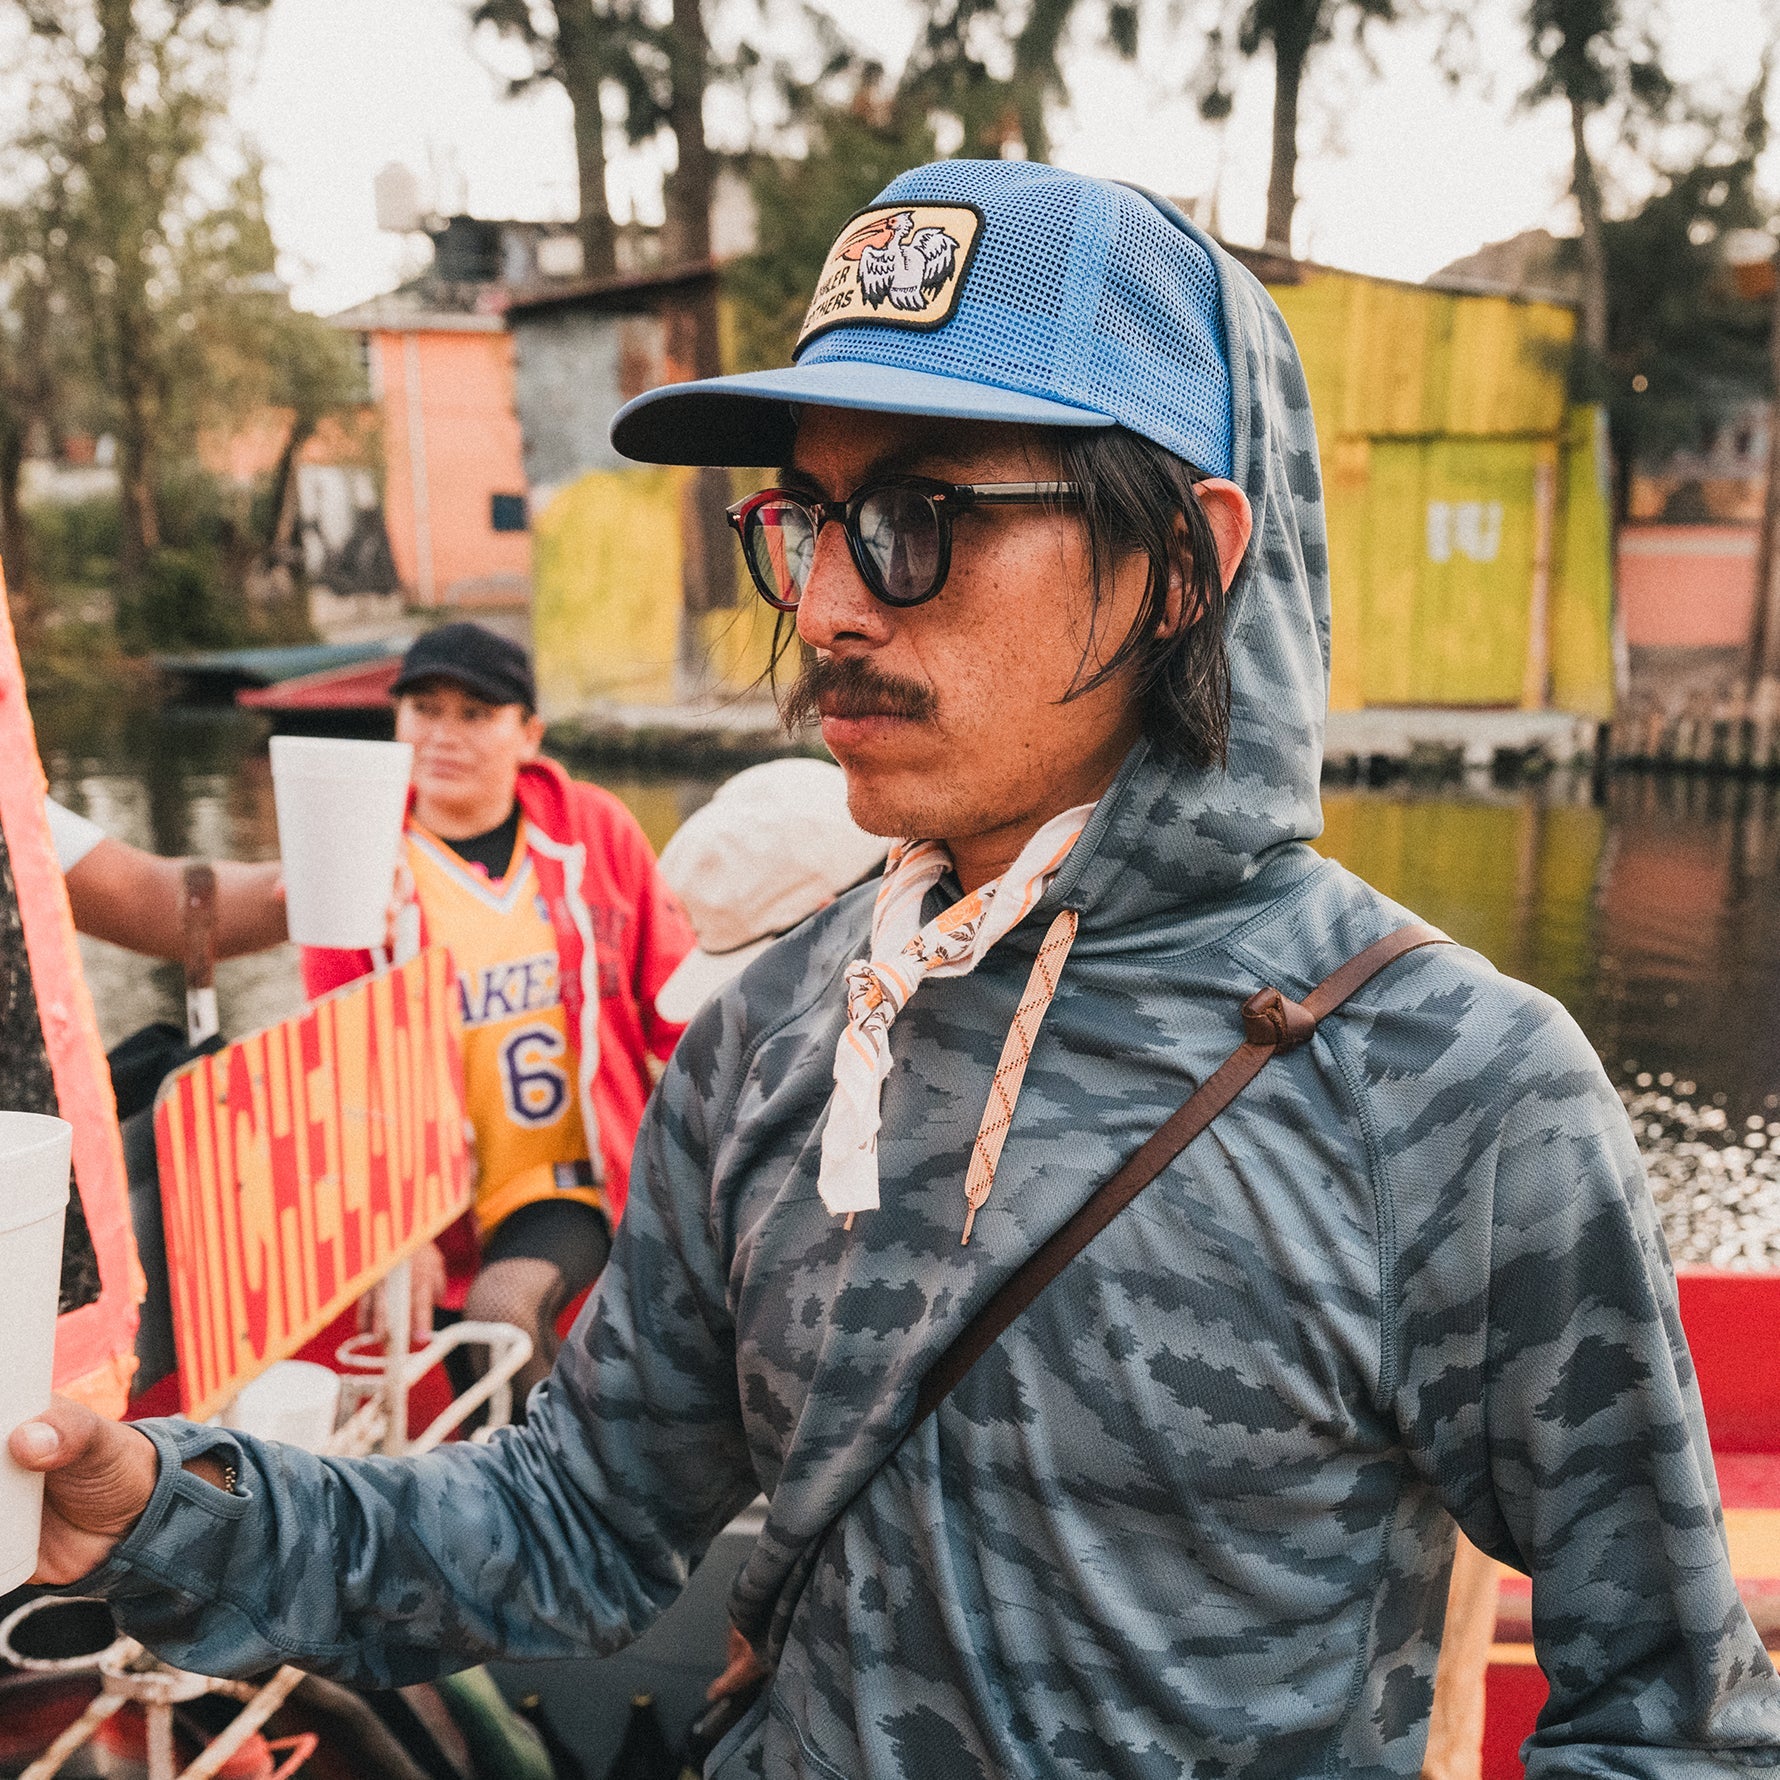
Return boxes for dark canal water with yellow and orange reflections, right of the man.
[1321,776,1780,1114]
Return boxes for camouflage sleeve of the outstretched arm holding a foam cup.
[78,1045,758,1687]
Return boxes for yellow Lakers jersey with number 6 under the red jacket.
[408,821,605,1235]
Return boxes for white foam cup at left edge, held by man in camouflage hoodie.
[0,1113,75,1595]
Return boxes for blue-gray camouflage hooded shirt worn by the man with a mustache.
[76,236,1780,1780]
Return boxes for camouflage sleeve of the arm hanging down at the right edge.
[1360,963,1780,1780]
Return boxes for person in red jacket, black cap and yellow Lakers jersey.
[303,623,692,1397]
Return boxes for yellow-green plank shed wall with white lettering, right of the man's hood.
[1273,269,1613,716]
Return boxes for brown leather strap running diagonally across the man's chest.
[910,922,1452,1428]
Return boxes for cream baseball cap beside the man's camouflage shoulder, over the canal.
[655,760,890,1024]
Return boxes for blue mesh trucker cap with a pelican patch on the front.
[612,160,1232,475]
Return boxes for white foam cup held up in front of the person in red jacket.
[272,735,415,951]
